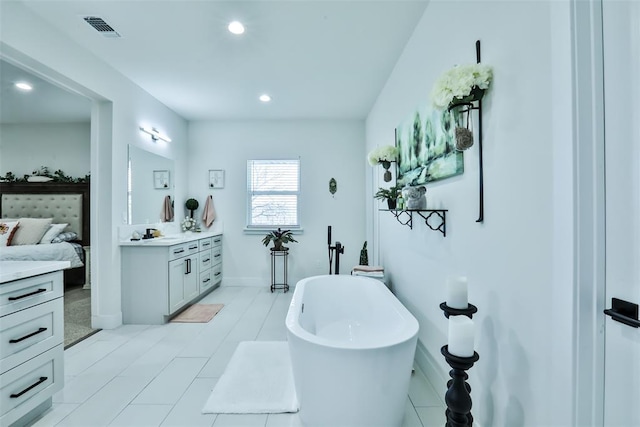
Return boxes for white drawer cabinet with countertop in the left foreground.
[0,261,69,426]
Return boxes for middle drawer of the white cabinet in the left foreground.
[0,298,64,374]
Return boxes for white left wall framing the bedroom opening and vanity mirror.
[0,2,187,328]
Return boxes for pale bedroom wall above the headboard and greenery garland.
[0,122,91,178]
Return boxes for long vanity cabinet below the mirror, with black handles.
[121,233,222,325]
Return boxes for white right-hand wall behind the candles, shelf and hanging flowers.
[366,1,573,426]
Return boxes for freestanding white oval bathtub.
[286,275,418,427]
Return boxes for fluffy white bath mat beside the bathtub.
[202,341,298,414]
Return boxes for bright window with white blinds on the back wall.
[247,160,300,229]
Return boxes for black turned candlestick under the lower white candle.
[440,345,480,427]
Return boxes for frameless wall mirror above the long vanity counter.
[127,144,175,224]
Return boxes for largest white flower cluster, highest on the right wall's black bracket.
[431,64,493,109]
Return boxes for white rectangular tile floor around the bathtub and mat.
[28,287,445,427]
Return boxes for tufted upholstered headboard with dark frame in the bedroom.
[0,183,90,246]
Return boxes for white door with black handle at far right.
[603,0,640,426]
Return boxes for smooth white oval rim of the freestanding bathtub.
[285,274,420,350]
